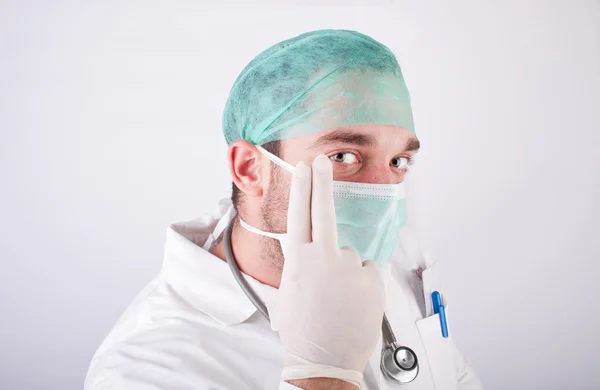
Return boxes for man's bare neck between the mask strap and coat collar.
[210,217,281,288]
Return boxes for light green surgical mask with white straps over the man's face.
[240,146,406,266]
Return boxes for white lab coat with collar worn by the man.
[85,201,482,390]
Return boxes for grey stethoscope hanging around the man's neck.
[223,218,419,384]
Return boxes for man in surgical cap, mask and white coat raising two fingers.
[85,30,481,390]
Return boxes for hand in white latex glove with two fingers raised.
[270,155,385,387]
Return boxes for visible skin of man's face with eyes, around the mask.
[261,124,420,254]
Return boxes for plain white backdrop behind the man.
[0,0,600,390]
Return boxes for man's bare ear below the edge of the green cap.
[227,139,264,196]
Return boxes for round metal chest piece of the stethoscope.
[381,342,419,384]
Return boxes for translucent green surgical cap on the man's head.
[223,30,415,145]
